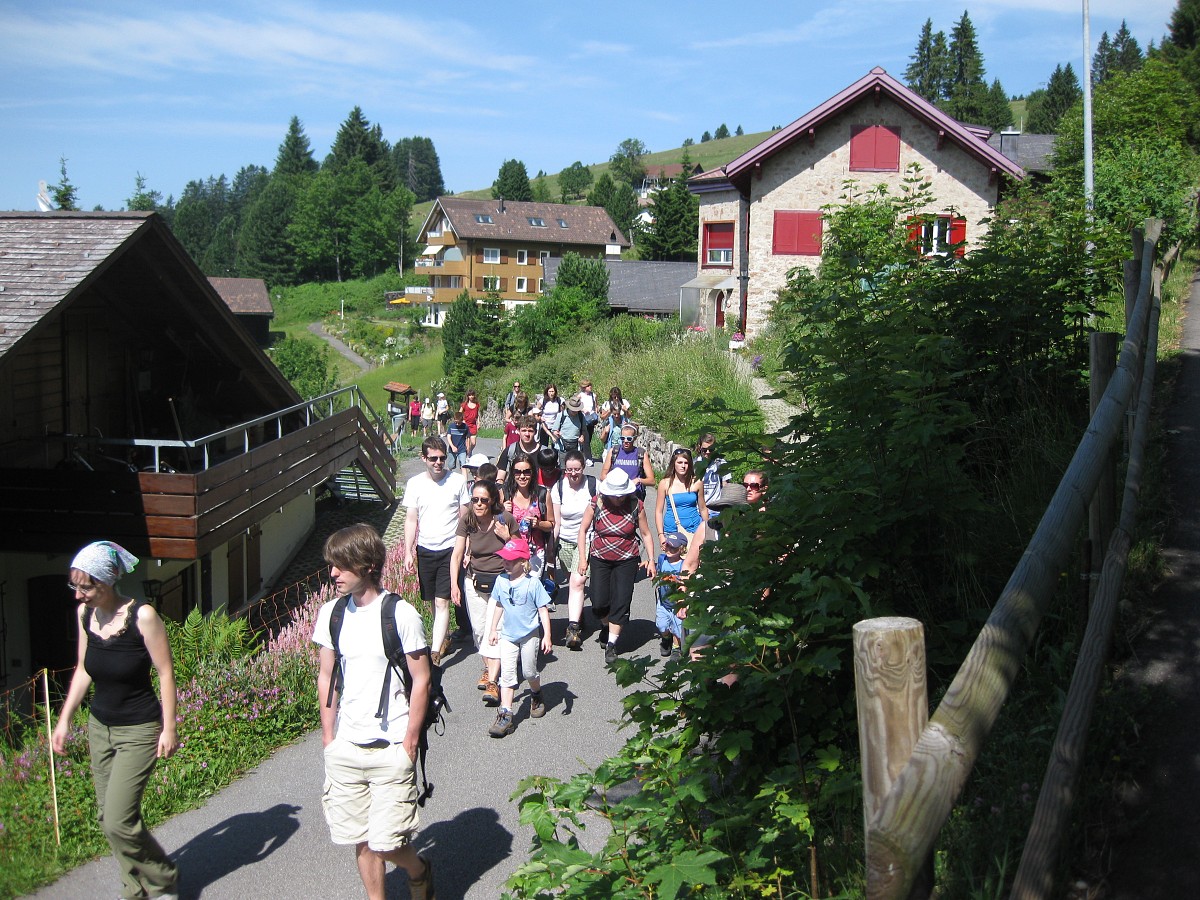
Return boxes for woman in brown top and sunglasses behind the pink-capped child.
[450,481,517,707]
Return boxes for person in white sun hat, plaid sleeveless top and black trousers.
[577,469,654,664]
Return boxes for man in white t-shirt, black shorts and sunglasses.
[402,436,470,665]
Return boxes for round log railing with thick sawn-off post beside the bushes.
[854,222,1169,900]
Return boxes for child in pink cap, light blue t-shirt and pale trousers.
[487,538,552,738]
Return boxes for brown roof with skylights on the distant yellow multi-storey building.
[421,197,629,247]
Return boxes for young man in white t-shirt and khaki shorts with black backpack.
[312,524,433,900]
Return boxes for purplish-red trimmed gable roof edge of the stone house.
[706,66,1025,194]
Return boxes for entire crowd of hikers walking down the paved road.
[52,380,768,900]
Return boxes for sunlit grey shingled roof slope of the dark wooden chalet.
[0,212,154,355]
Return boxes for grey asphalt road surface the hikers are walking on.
[35,440,658,900]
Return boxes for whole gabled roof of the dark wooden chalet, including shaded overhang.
[0,211,300,404]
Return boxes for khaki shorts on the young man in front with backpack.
[320,738,420,853]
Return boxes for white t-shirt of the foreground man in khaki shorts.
[312,594,428,744]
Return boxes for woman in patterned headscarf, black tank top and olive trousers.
[50,541,179,900]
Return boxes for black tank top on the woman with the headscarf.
[83,601,162,726]
